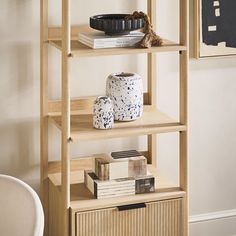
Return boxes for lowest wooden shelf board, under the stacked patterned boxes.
[49,165,185,211]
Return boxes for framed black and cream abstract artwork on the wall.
[194,0,236,58]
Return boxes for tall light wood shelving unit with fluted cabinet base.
[40,0,188,236]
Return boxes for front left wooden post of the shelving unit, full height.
[61,0,71,236]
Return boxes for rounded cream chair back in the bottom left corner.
[0,175,44,236]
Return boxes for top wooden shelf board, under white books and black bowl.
[49,40,186,57]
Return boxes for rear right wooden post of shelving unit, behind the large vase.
[147,0,157,166]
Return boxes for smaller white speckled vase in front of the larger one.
[93,96,114,129]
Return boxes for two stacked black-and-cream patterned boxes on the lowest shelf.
[84,150,155,199]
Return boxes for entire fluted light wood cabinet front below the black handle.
[75,199,182,236]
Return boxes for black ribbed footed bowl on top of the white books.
[90,14,144,35]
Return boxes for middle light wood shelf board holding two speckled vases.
[49,106,186,140]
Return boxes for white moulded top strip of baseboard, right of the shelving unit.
[189,209,236,224]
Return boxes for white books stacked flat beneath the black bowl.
[79,31,144,49]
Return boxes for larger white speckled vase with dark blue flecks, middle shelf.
[106,72,143,121]
